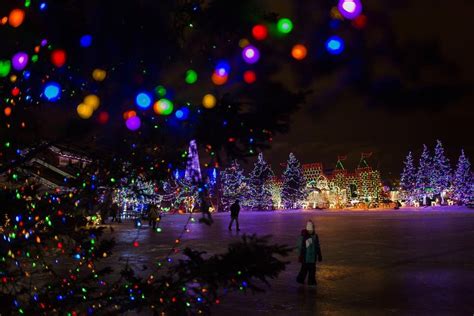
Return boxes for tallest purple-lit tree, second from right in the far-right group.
[431,140,451,204]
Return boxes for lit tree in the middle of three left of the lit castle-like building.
[245,153,274,210]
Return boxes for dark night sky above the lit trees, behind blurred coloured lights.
[0,0,474,178]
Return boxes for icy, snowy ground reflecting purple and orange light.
[110,206,474,316]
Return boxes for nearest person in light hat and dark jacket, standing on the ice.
[296,220,323,285]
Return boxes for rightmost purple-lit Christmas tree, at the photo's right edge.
[453,150,474,204]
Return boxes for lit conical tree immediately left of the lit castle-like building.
[281,153,306,209]
